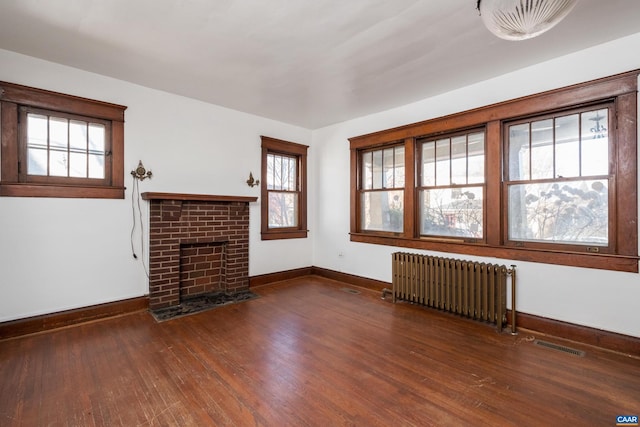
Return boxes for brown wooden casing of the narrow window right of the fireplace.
[260,136,309,240]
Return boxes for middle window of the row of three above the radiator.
[417,131,485,241]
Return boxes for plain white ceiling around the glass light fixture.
[0,0,640,129]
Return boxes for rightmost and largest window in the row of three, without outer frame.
[505,104,615,252]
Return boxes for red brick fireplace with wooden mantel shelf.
[142,193,257,310]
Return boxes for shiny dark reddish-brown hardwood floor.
[0,276,640,426]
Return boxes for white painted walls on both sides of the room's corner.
[0,34,640,337]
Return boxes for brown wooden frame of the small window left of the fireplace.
[0,82,127,199]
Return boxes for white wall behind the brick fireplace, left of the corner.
[0,50,314,321]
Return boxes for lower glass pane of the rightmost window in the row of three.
[509,180,609,246]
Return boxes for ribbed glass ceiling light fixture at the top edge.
[476,0,577,40]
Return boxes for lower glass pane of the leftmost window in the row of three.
[361,190,404,232]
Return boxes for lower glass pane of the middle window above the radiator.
[420,187,484,238]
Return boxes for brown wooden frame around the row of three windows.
[349,70,640,273]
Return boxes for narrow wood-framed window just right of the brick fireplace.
[261,136,308,240]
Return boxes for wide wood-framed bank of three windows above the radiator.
[349,71,639,272]
